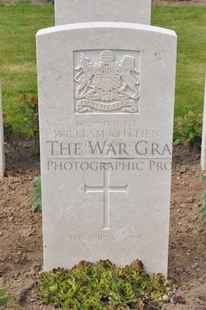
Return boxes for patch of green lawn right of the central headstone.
[152,6,206,117]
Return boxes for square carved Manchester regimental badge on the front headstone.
[74,50,140,113]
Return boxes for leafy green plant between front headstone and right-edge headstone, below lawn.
[174,111,202,147]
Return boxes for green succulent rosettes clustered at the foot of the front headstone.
[37,260,170,310]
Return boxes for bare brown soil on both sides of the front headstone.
[0,147,206,310]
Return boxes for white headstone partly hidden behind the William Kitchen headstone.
[55,0,151,25]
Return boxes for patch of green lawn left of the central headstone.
[0,4,54,134]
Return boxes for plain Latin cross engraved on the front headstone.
[84,169,128,230]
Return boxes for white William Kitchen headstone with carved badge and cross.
[37,23,176,275]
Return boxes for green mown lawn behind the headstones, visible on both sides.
[0,4,206,134]
